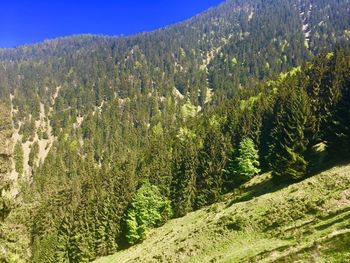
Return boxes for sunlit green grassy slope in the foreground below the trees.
[96,165,350,263]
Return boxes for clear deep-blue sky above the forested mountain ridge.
[0,0,223,47]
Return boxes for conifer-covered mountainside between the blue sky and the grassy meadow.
[0,0,350,263]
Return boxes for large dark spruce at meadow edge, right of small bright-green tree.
[269,83,314,180]
